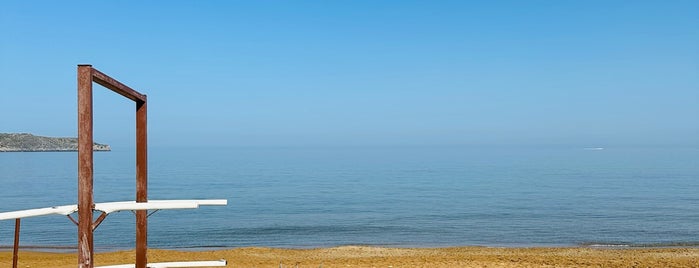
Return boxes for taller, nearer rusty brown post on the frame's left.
[78,65,95,268]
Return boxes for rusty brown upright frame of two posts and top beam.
[78,64,148,268]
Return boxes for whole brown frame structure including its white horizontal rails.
[0,64,228,268]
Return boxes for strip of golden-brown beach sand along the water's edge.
[0,246,699,268]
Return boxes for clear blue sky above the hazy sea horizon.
[0,0,699,147]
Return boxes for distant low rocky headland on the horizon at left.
[0,133,112,152]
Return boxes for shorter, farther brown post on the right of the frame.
[136,99,148,268]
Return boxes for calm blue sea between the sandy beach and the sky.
[0,146,699,249]
